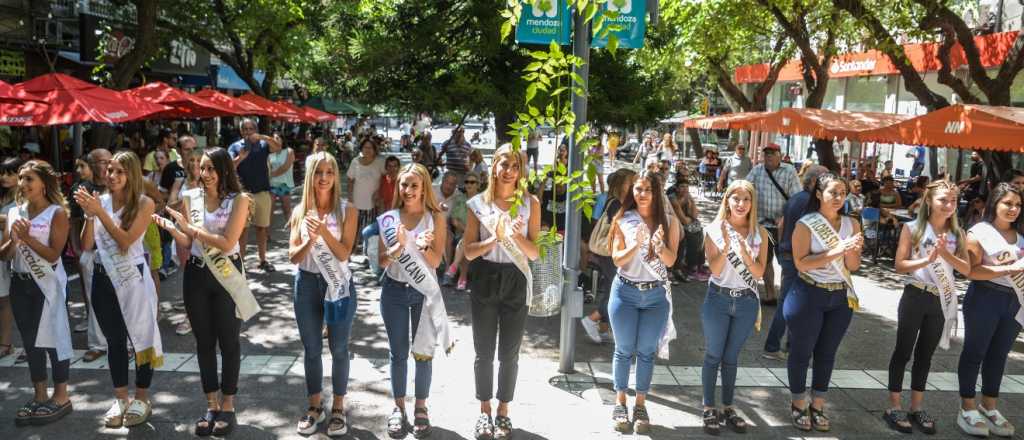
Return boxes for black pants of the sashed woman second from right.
[889,285,945,393]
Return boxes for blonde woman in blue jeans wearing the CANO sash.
[377,164,450,438]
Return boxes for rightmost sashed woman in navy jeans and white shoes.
[956,183,1024,437]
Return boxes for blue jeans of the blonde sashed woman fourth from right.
[700,284,761,407]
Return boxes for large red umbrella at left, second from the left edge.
[3,74,169,126]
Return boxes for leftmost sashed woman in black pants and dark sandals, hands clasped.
[0,161,74,425]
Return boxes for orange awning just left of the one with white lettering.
[732,108,911,141]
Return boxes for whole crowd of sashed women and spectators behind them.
[0,120,1024,440]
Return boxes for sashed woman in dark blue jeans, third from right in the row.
[782,173,864,432]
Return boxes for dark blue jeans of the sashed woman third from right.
[782,278,853,399]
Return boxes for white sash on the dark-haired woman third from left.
[187,188,260,321]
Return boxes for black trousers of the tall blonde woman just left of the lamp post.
[469,258,527,402]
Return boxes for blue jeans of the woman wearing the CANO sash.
[381,275,433,399]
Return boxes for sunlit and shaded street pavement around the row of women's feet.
[0,163,1024,440]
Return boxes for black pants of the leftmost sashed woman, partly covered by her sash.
[10,275,71,385]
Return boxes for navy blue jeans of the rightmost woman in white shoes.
[956,281,1021,398]
